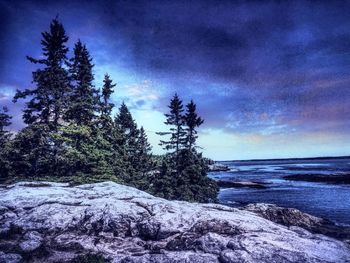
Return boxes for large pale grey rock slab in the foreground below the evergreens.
[0,182,350,263]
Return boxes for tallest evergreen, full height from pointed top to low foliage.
[14,18,71,175]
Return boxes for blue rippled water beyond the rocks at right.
[209,158,350,225]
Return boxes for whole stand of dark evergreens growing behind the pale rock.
[0,19,218,202]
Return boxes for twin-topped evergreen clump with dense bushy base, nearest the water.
[157,94,218,202]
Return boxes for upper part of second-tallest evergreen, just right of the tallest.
[65,40,97,126]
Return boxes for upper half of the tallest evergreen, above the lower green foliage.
[14,18,70,131]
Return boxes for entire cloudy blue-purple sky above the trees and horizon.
[0,0,350,160]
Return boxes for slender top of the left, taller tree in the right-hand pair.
[157,94,186,156]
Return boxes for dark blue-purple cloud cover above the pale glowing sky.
[0,1,350,138]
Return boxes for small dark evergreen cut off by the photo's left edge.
[0,107,12,181]
